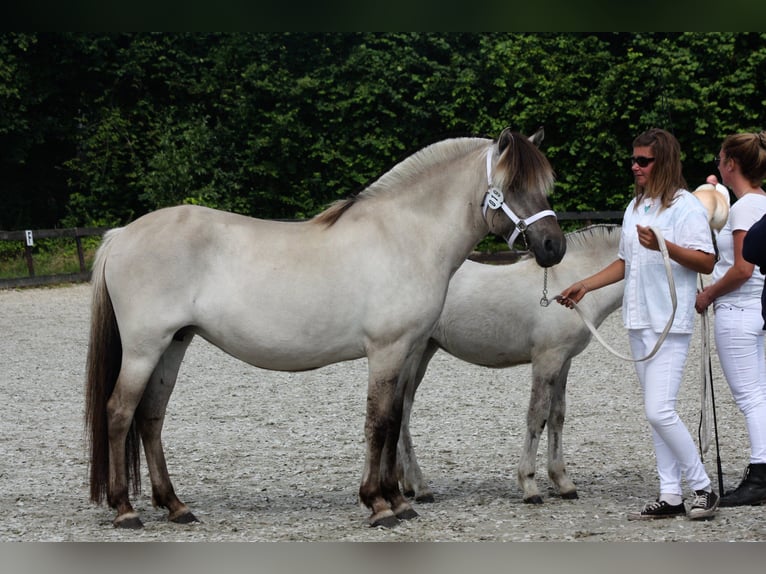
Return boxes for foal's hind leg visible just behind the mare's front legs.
[396,341,439,502]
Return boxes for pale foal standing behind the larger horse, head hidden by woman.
[397,225,624,504]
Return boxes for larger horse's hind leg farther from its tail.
[136,333,198,524]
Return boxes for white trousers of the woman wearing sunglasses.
[628,329,710,496]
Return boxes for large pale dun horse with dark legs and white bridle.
[85,129,566,528]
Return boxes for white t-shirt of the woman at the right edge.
[712,193,766,309]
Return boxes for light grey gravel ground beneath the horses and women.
[0,284,766,542]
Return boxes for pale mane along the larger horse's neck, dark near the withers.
[312,137,489,227]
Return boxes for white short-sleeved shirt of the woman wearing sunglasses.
[618,189,714,333]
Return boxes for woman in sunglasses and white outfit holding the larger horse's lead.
[559,129,719,520]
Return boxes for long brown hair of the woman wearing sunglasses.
[633,128,686,208]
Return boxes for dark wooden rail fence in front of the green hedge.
[0,211,623,289]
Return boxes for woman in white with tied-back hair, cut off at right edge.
[695,132,766,506]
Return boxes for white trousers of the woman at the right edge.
[715,305,766,464]
